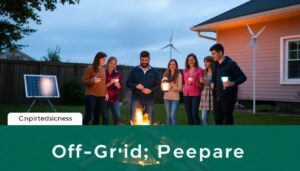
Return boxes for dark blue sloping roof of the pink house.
[193,0,300,28]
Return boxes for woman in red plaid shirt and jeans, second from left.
[105,57,122,125]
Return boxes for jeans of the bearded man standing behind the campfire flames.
[130,98,154,122]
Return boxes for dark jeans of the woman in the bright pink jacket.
[184,96,201,125]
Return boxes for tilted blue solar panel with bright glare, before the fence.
[24,74,60,98]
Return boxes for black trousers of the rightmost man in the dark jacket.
[214,95,237,125]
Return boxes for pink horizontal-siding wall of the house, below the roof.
[217,16,300,102]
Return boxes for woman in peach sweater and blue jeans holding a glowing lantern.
[161,59,182,125]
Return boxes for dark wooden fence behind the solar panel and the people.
[0,60,164,105]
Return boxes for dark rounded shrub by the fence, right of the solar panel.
[62,79,85,105]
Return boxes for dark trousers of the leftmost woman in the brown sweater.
[83,95,108,125]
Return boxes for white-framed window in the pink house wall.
[280,35,300,84]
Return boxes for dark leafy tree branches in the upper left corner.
[0,0,79,54]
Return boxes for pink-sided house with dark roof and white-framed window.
[191,0,300,106]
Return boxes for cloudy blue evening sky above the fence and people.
[20,0,247,68]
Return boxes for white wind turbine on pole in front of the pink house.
[247,25,266,114]
